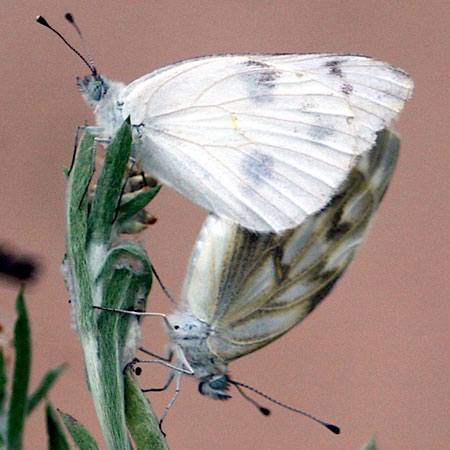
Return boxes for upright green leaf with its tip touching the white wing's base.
[89,118,131,244]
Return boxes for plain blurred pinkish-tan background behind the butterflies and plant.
[0,0,450,450]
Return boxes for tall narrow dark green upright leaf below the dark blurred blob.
[7,289,31,450]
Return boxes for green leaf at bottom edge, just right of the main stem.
[124,369,169,450]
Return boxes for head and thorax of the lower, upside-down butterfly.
[167,312,230,400]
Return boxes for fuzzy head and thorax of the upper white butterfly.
[77,75,125,138]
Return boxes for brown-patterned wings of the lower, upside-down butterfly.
[183,130,399,360]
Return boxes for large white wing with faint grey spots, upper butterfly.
[122,54,413,232]
